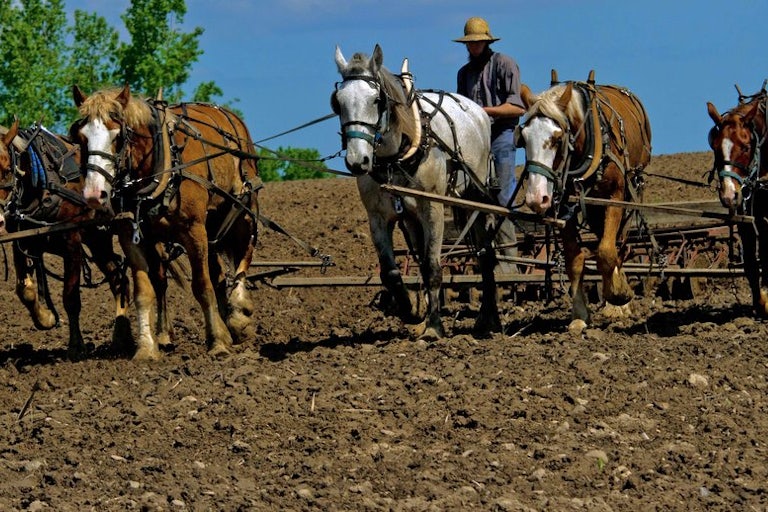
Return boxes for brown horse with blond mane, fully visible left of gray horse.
[71,86,261,359]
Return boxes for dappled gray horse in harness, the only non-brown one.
[331,44,501,340]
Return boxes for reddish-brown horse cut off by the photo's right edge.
[707,84,768,317]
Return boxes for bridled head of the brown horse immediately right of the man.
[519,83,574,215]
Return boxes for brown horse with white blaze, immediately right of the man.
[521,72,651,332]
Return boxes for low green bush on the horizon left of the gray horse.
[259,146,331,181]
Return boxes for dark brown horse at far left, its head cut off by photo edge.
[0,121,129,359]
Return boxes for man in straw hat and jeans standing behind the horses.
[454,17,525,270]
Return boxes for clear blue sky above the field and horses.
[66,0,768,165]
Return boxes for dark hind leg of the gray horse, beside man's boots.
[473,213,502,337]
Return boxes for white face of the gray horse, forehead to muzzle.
[336,80,379,174]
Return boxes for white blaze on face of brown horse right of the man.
[522,117,563,215]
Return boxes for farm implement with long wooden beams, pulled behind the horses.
[249,185,753,304]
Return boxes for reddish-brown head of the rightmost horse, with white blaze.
[707,95,768,211]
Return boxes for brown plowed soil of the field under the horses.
[0,153,768,512]
